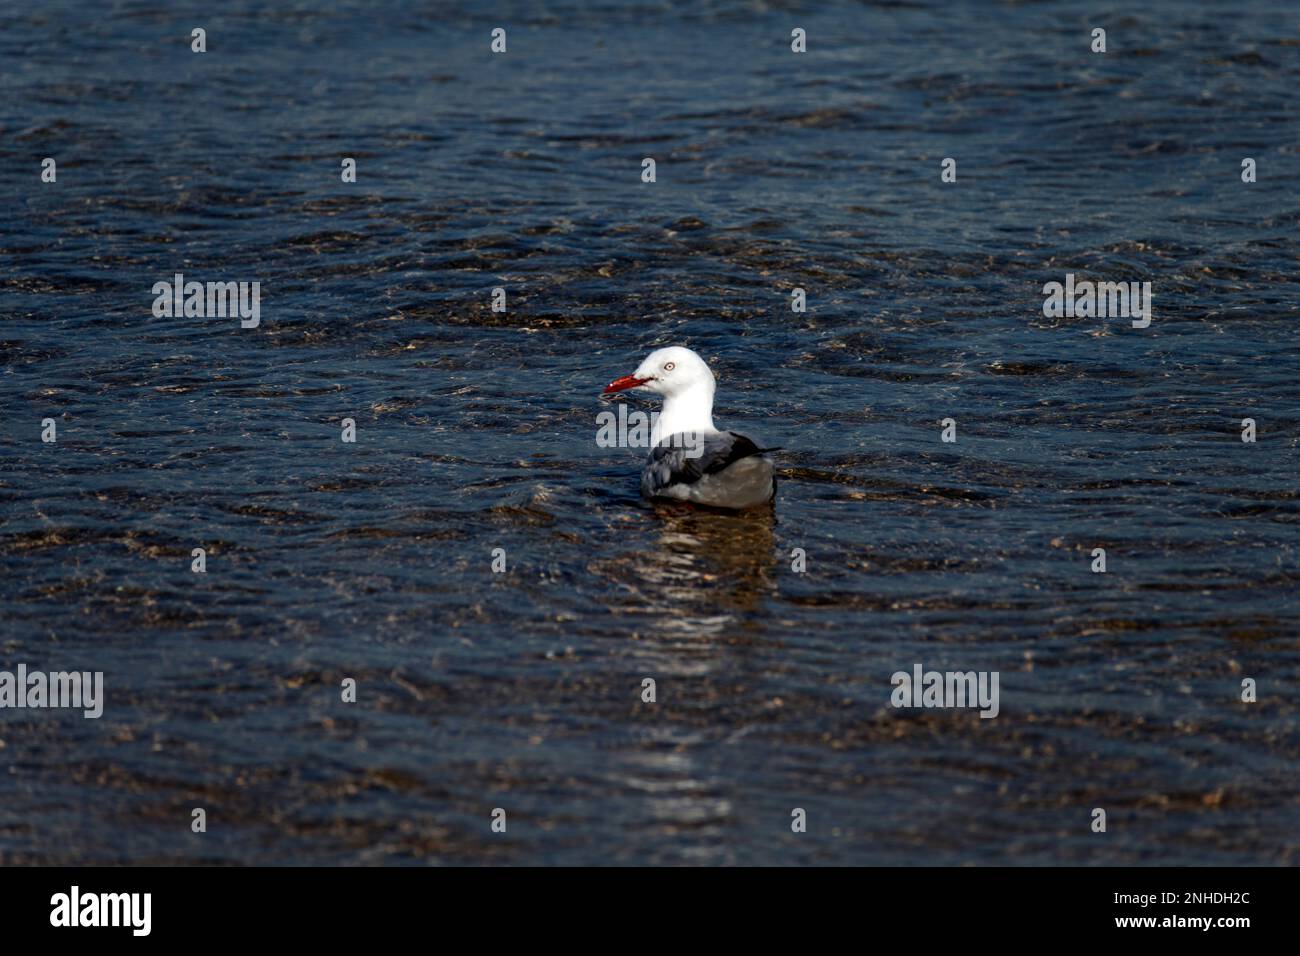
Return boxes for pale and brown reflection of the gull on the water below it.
[610,503,781,864]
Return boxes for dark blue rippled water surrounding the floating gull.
[0,0,1300,864]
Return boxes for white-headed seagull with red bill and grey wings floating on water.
[603,346,776,511]
